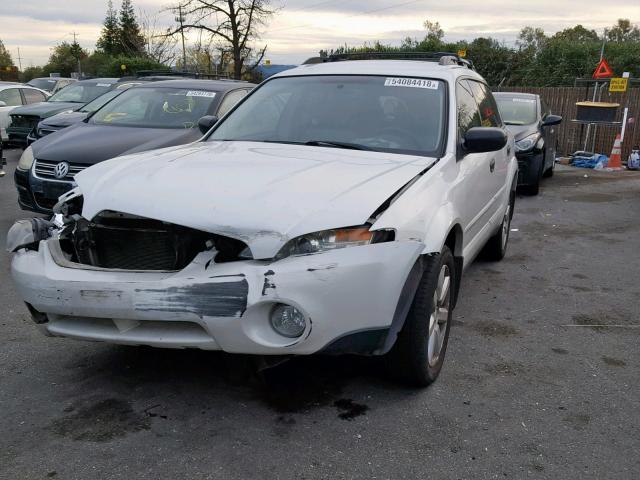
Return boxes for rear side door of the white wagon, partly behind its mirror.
[469,80,511,217]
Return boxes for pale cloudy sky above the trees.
[0,0,640,68]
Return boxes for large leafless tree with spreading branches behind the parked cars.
[169,0,275,79]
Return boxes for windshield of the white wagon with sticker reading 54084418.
[207,75,446,156]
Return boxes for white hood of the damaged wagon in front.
[75,142,436,259]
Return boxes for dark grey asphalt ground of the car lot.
[0,151,640,480]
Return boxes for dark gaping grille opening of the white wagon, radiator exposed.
[60,212,251,271]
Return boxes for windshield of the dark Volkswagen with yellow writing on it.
[89,87,216,128]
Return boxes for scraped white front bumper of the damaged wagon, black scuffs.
[12,238,423,355]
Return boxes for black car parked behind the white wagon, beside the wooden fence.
[494,92,562,195]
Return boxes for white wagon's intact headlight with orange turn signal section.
[276,226,395,260]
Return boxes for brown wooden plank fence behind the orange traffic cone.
[494,87,640,160]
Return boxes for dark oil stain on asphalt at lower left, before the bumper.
[49,398,150,442]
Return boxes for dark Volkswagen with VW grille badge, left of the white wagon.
[14,80,254,213]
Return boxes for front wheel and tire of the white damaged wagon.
[385,246,457,387]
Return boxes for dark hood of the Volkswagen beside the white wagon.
[32,122,202,165]
